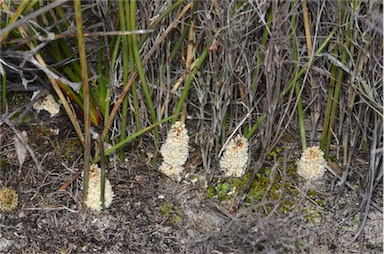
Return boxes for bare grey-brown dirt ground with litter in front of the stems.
[0,104,383,253]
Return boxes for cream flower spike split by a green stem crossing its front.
[85,164,114,211]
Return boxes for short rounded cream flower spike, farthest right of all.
[297,146,326,181]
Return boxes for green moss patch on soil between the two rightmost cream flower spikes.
[206,147,324,221]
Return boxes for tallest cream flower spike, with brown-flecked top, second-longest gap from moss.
[160,122,189,180]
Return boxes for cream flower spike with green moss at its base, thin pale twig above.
[220,135,248,177]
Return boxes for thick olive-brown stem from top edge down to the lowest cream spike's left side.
[74,0,91,205]
